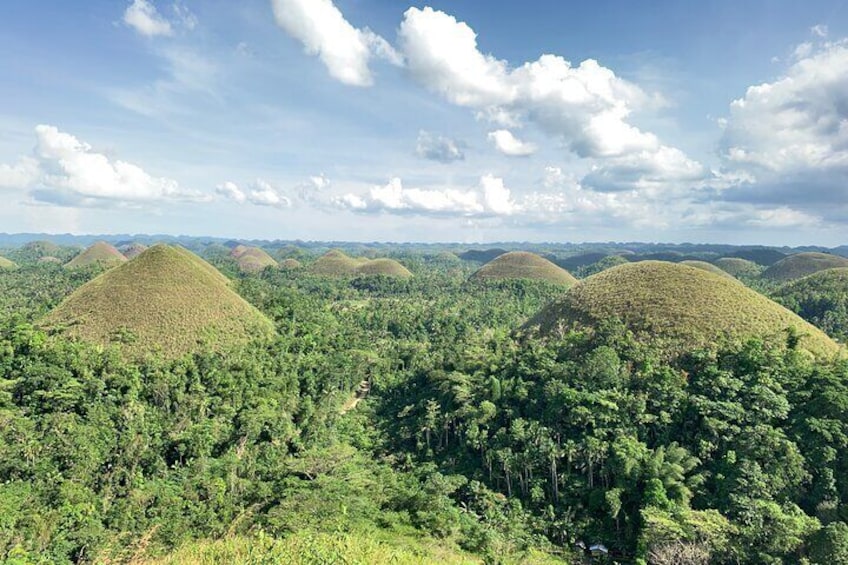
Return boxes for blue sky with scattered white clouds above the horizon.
[0,0,848,246]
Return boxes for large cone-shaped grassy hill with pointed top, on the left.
[43,245,273,358]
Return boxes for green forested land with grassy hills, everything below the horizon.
[0,242,848,565]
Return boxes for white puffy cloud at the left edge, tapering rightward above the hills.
[0,125,203,206]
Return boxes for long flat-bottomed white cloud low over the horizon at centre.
[333,175,514,216]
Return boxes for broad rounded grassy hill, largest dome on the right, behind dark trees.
[525,261,839,356]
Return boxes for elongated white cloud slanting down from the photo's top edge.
[271,0,402,86]
